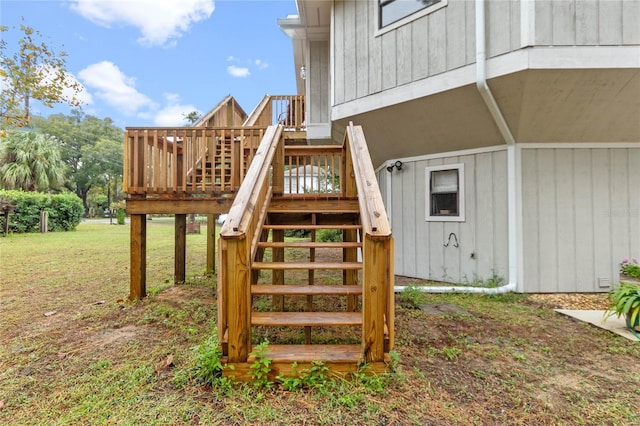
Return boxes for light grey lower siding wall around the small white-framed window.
[388,150,508,283]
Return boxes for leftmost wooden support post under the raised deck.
[129,214,147,300]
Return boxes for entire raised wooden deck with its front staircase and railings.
[124,98,394,380]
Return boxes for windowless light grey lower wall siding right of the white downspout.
[522,148,640,293]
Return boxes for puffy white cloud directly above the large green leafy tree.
[78,61,154,115]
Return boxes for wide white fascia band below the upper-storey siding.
[331,46,640,121]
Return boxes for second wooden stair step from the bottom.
[251,312,362,327]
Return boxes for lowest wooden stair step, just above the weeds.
[248,345,362,363]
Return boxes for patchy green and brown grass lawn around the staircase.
[0,220,640,425]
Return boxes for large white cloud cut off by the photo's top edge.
[71,0,215,46]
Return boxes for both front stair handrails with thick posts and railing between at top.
[218,124,394,363]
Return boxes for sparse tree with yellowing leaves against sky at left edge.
[0,24,82,130]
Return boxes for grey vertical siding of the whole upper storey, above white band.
[331,0,640,105]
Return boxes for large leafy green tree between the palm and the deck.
[32,111,124,213]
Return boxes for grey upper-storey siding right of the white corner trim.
[534,0,640,46]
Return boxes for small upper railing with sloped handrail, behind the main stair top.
[244,95,306,131]
